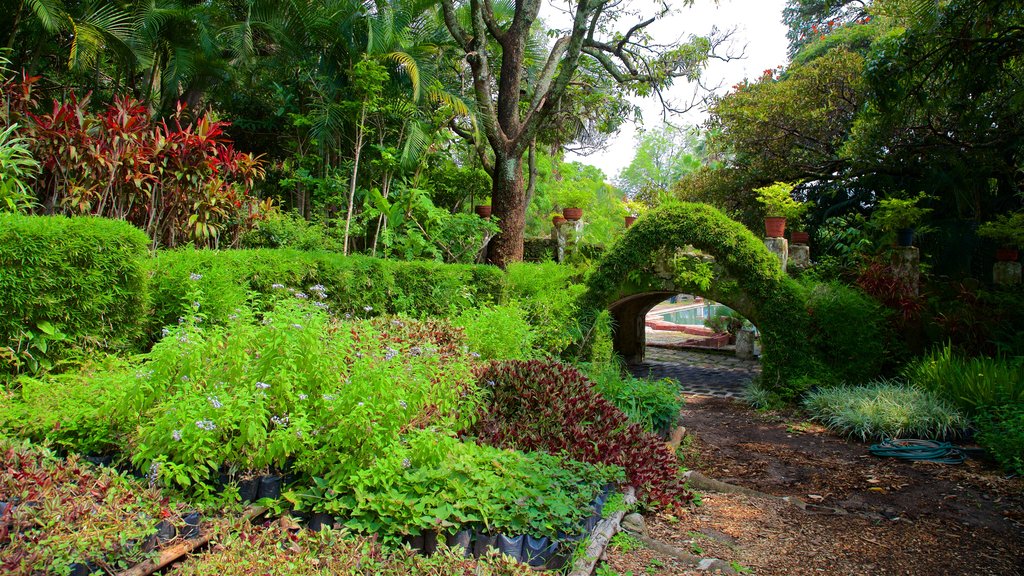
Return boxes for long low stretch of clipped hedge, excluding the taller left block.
[150,245,505,334]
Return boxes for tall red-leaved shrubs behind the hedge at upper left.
[0,76,265,246]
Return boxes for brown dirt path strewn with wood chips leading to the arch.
[607,397,1024,576]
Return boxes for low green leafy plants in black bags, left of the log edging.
[301,429,622,542]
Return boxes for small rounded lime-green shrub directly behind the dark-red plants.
[453,302,536,360]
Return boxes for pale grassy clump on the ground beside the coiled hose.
[804,380,967,441]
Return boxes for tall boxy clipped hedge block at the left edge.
[0,214,148,374]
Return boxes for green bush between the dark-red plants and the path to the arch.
[584,363,683,434]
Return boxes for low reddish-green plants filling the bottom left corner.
[0,438,194,576]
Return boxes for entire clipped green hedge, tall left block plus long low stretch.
[0,214,505,375]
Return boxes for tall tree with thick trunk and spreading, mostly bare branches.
[440,0,721,265]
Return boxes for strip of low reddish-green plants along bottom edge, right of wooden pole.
[175,524,535,576]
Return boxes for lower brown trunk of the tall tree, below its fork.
[487,151,526,269]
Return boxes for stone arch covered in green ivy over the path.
[582,203,824,397]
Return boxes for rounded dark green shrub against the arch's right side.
[803,282,888,383]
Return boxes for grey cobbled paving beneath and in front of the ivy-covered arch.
[630,346,761,398]
